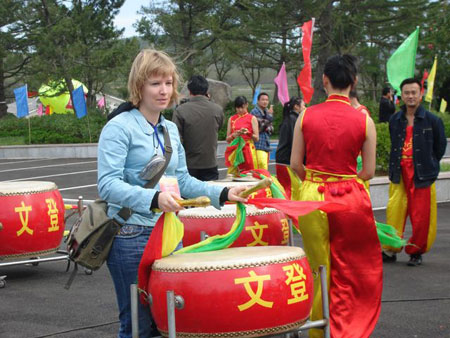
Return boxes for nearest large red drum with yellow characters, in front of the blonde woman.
[148,246,313,337]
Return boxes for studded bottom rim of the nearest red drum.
[158,316,309,338]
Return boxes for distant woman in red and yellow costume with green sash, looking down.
[225,96,259,175]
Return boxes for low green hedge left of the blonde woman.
[0,109,106,144]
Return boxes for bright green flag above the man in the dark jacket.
[386,27,419,93]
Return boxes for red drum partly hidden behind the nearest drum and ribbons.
[178,204,289,247]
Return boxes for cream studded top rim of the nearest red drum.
[152,247,306,273]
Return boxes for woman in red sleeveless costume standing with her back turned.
[291,55,383,338]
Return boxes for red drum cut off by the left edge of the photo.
[0,181,64,260]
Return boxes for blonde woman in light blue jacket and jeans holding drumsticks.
[98,49,245,338]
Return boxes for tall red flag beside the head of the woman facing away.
[297,18,314,103]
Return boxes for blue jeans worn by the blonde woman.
[107,225,159,338]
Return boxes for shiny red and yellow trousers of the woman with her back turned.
[299,170,383,338]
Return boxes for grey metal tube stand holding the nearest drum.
[130,220,330,338]
